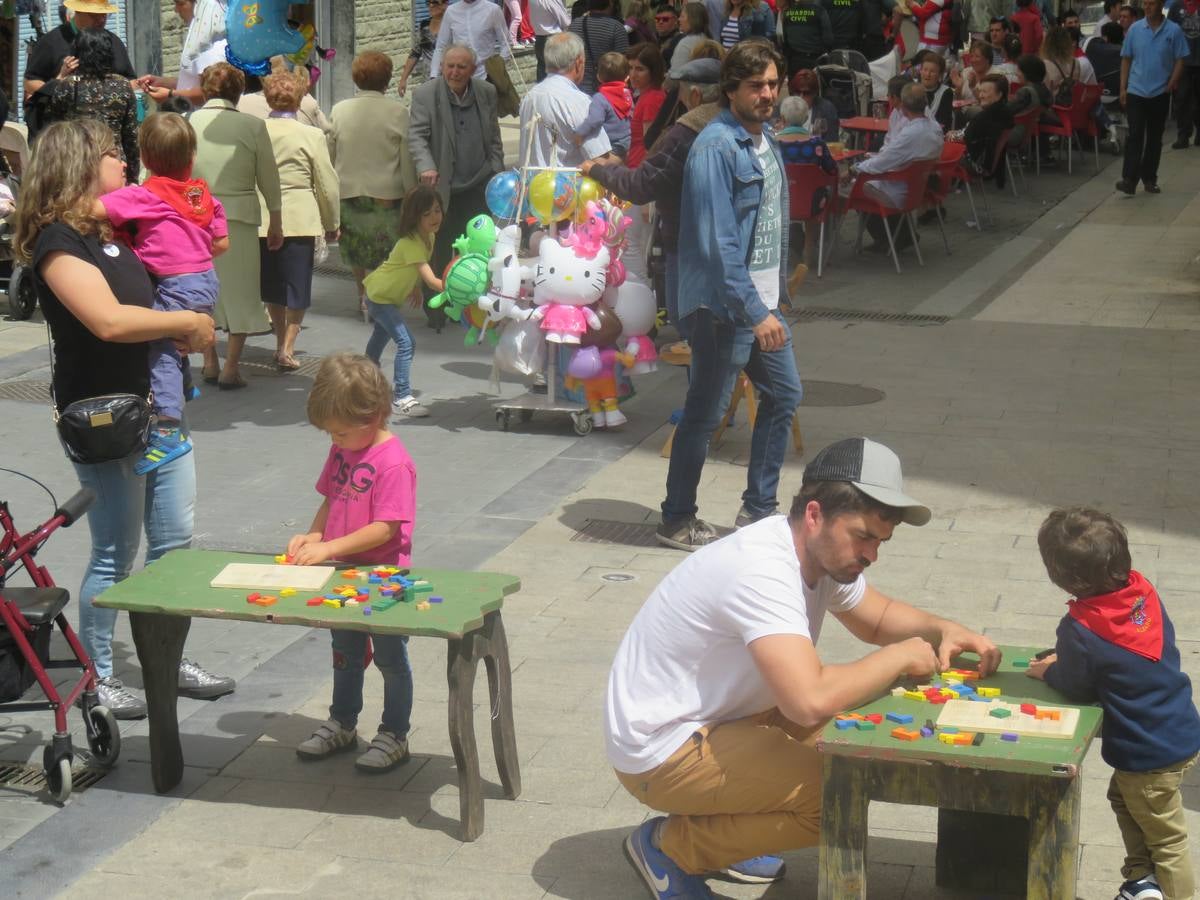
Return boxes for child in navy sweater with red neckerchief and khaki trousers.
[1028,508,1200,900]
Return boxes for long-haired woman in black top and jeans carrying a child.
[16,119,234,719]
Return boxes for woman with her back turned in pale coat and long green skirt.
[188,62,283,390]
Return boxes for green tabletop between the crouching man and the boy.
[817,647,1102,778]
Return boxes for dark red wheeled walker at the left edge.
[0,488,121,803]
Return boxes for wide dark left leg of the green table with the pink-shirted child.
[130,612,192,793]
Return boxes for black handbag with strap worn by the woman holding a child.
[46,325,156,466]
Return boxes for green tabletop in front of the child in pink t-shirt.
[95,550,521,638]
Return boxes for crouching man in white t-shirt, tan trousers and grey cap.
[605,438,1000,899]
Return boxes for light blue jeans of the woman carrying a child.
[74,454,196,678]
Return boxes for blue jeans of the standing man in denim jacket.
[662,307,803,523]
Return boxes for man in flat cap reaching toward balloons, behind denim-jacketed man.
[580,59,721,326]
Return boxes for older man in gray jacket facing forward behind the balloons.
[408,44,504,328]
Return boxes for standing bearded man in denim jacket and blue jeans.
[658,40,800,551]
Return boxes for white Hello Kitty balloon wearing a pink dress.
[533,238,608,343]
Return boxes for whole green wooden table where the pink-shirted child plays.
[95,550,521,841]
